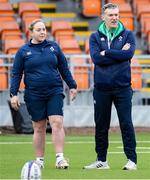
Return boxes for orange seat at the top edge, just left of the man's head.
[81,0,101,17]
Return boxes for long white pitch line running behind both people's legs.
[0,141,150,144]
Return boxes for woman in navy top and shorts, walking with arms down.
[10,19,77,169]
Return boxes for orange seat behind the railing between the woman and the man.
[70,58,89,91]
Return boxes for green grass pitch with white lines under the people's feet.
[0,133,150,180]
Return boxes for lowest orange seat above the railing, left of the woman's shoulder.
[4,39,24,54]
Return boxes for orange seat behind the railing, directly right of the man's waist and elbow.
[131,58,142,91]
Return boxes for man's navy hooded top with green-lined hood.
[89,22,135,90]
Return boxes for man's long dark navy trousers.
[93,87,137,163]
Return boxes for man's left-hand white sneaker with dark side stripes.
[83,161,110,169]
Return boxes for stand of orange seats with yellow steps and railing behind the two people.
[0,0,150,128]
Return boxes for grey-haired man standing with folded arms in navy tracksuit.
[84,3,137,170]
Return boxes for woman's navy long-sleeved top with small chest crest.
[10,40,77,97]
